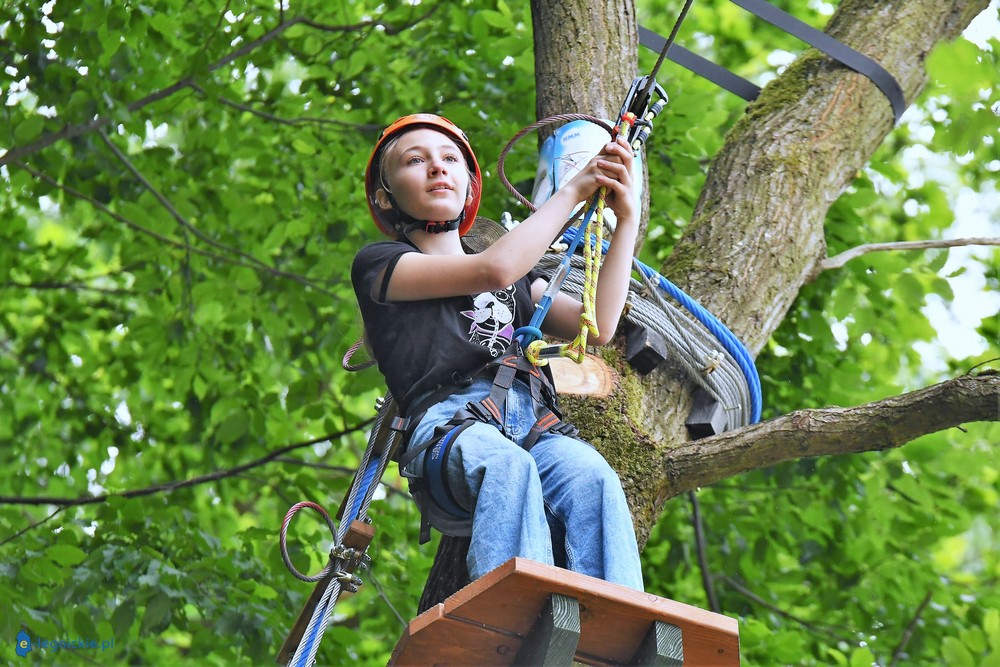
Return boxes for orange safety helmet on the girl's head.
[365,113,483,238]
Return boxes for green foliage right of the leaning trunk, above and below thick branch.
[643,2,1000,666]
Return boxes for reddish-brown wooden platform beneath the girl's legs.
[389,558,740,667]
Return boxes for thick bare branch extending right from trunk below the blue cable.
[663,370,1000,497]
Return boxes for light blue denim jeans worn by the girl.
[406,378,643,590]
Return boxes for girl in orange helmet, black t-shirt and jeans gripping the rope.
[351,114,643,590]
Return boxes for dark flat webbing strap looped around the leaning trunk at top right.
[639,0,906,122]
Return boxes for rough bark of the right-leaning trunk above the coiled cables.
[663,0,988,352]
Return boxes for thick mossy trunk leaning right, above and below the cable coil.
[566,0,997,544]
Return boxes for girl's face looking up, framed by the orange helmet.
[375,128,472,221]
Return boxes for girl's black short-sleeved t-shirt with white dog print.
[351,241,536,413]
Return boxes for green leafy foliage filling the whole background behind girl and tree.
[0,0,1000,666]
